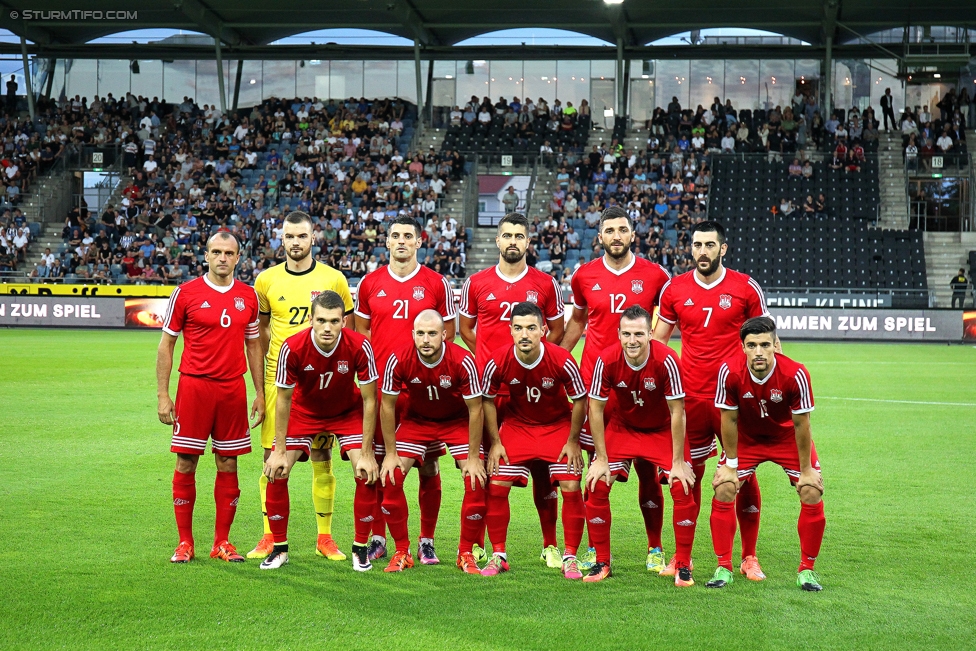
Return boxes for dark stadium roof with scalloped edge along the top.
[0,0,976,56]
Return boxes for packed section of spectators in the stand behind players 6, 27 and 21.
[41,95,471,284]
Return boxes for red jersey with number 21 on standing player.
[355,265,457,368]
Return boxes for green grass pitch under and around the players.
[0,330,976,651]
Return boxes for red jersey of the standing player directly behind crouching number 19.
[461,265,565,371]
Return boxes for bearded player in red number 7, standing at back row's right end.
[654,221,769,581]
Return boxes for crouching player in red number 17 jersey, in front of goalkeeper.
[261,290,383,572]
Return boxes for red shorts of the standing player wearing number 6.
[170,375,251,457]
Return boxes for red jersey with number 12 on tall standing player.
[571,255,671,382]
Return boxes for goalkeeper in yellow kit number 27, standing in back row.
[247,211,353,561]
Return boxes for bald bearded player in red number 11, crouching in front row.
[380,310,486,574]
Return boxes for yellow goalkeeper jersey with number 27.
[254,261,353,374]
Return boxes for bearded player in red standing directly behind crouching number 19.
[458,213,565,568]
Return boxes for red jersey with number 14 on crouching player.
[590,340,685,432]
